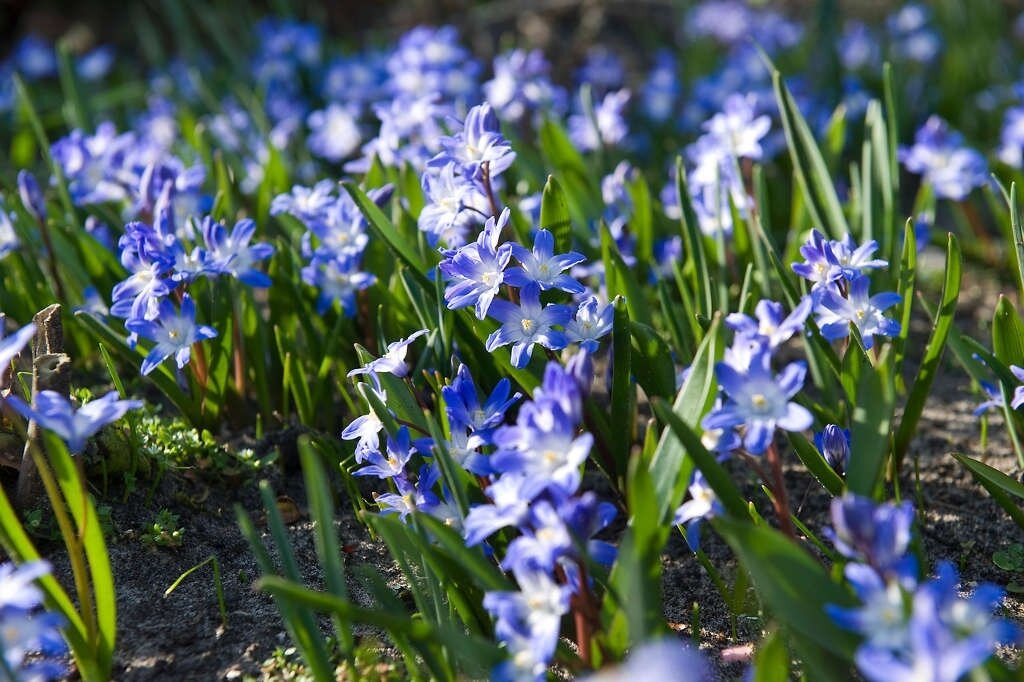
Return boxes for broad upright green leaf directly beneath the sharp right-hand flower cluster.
[846,344,896,497]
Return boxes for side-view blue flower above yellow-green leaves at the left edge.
[7,391,142,454]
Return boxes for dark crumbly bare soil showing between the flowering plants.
[24,253,1024,681]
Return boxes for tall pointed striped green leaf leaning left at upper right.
[768,66,850,239]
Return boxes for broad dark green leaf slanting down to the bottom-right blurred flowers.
[712,517,859,659]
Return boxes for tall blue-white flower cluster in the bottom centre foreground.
[464,363,615,680]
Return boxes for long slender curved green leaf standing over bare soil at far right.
[893,232,962,464]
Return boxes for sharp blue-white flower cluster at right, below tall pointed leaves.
[793,229,902,349]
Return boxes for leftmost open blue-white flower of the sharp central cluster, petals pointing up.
[438,208,512,319]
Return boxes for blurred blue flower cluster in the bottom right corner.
[826,496,1019,682]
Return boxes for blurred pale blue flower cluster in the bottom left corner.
[0,561,68,680]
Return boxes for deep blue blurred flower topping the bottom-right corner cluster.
[825,495,913,574]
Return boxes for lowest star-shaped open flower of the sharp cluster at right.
[817,274,903,348]
